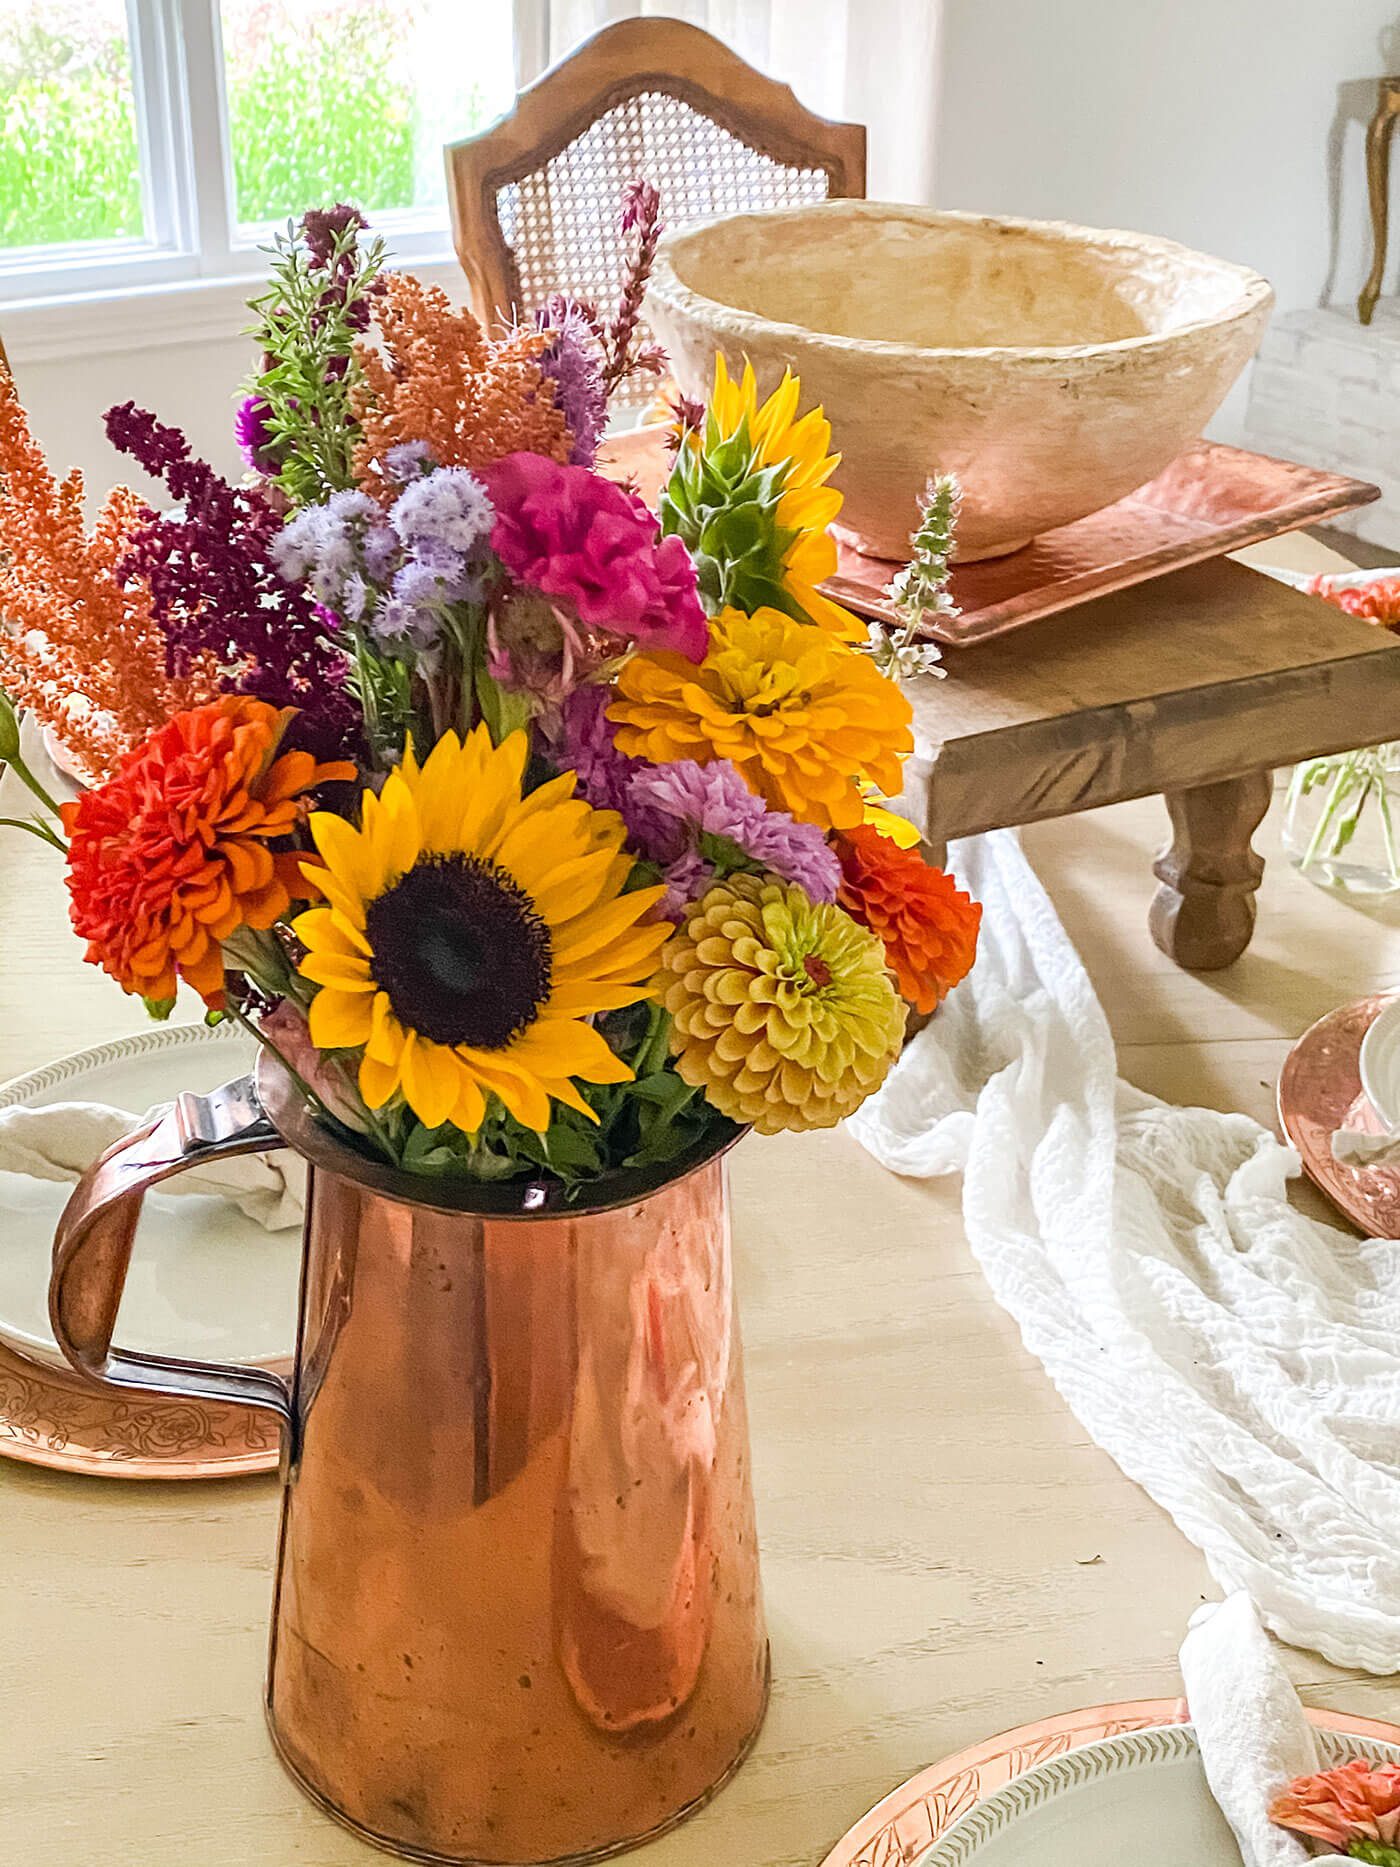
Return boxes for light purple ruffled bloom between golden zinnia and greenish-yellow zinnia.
[627,758,842,902]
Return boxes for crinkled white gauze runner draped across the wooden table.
[847,831,1400,1673]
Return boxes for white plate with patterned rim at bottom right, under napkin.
[922,1725,1400,1867]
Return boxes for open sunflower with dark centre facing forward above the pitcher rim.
[295,726,670,1135]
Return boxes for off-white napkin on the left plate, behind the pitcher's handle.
[0,1102,306,1232]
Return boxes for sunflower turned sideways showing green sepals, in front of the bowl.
[661,355,866,640]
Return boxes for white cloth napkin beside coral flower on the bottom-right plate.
[1182,1593,1338,1867]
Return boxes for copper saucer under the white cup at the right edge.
[1279,991,1400,1238]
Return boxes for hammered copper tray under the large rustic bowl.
[823,441,1379,648]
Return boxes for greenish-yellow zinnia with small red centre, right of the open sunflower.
[659,876,905,1135]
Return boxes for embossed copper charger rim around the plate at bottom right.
[821,1699,1400,1867]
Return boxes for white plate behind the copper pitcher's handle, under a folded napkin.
[0,1025,301,1367]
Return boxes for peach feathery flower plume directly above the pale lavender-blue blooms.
[351,273,573,487]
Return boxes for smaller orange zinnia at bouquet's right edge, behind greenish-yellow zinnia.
[836,823,982,1012]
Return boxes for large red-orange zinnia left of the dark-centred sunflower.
[63,695,355,1006]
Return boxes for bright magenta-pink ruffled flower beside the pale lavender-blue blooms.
[480,454,709,661]
